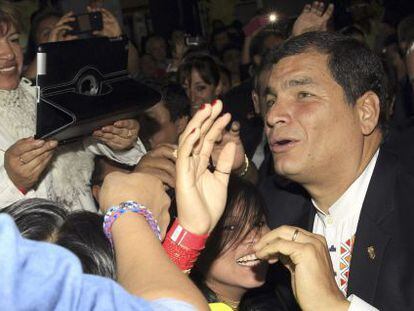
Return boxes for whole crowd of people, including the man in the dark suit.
[0,0,414,311]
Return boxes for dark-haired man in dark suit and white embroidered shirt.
[255,32,414,310]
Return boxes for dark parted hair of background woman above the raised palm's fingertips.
[178,54,220,86]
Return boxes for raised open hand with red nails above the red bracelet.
[176,100,236,235]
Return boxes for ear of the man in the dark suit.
[356,91,381,135]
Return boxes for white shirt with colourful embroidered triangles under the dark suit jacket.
[312,150,379,310]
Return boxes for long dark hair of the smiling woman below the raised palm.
[191,176,265,279]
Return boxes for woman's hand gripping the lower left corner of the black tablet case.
[4,137,57,190]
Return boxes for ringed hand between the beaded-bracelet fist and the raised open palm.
[134,144,177,188]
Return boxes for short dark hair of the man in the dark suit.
[261,32,389,131]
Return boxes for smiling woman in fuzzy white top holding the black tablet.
[0,1,144,211]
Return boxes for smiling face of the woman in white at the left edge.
[0,24,23,90]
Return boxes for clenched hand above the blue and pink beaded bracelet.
[99,172,171,236]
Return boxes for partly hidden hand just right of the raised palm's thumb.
[211,121,245,172]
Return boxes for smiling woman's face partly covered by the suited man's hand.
[206,218,269,299]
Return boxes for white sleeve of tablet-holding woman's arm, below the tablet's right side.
[83,137,147,166]
